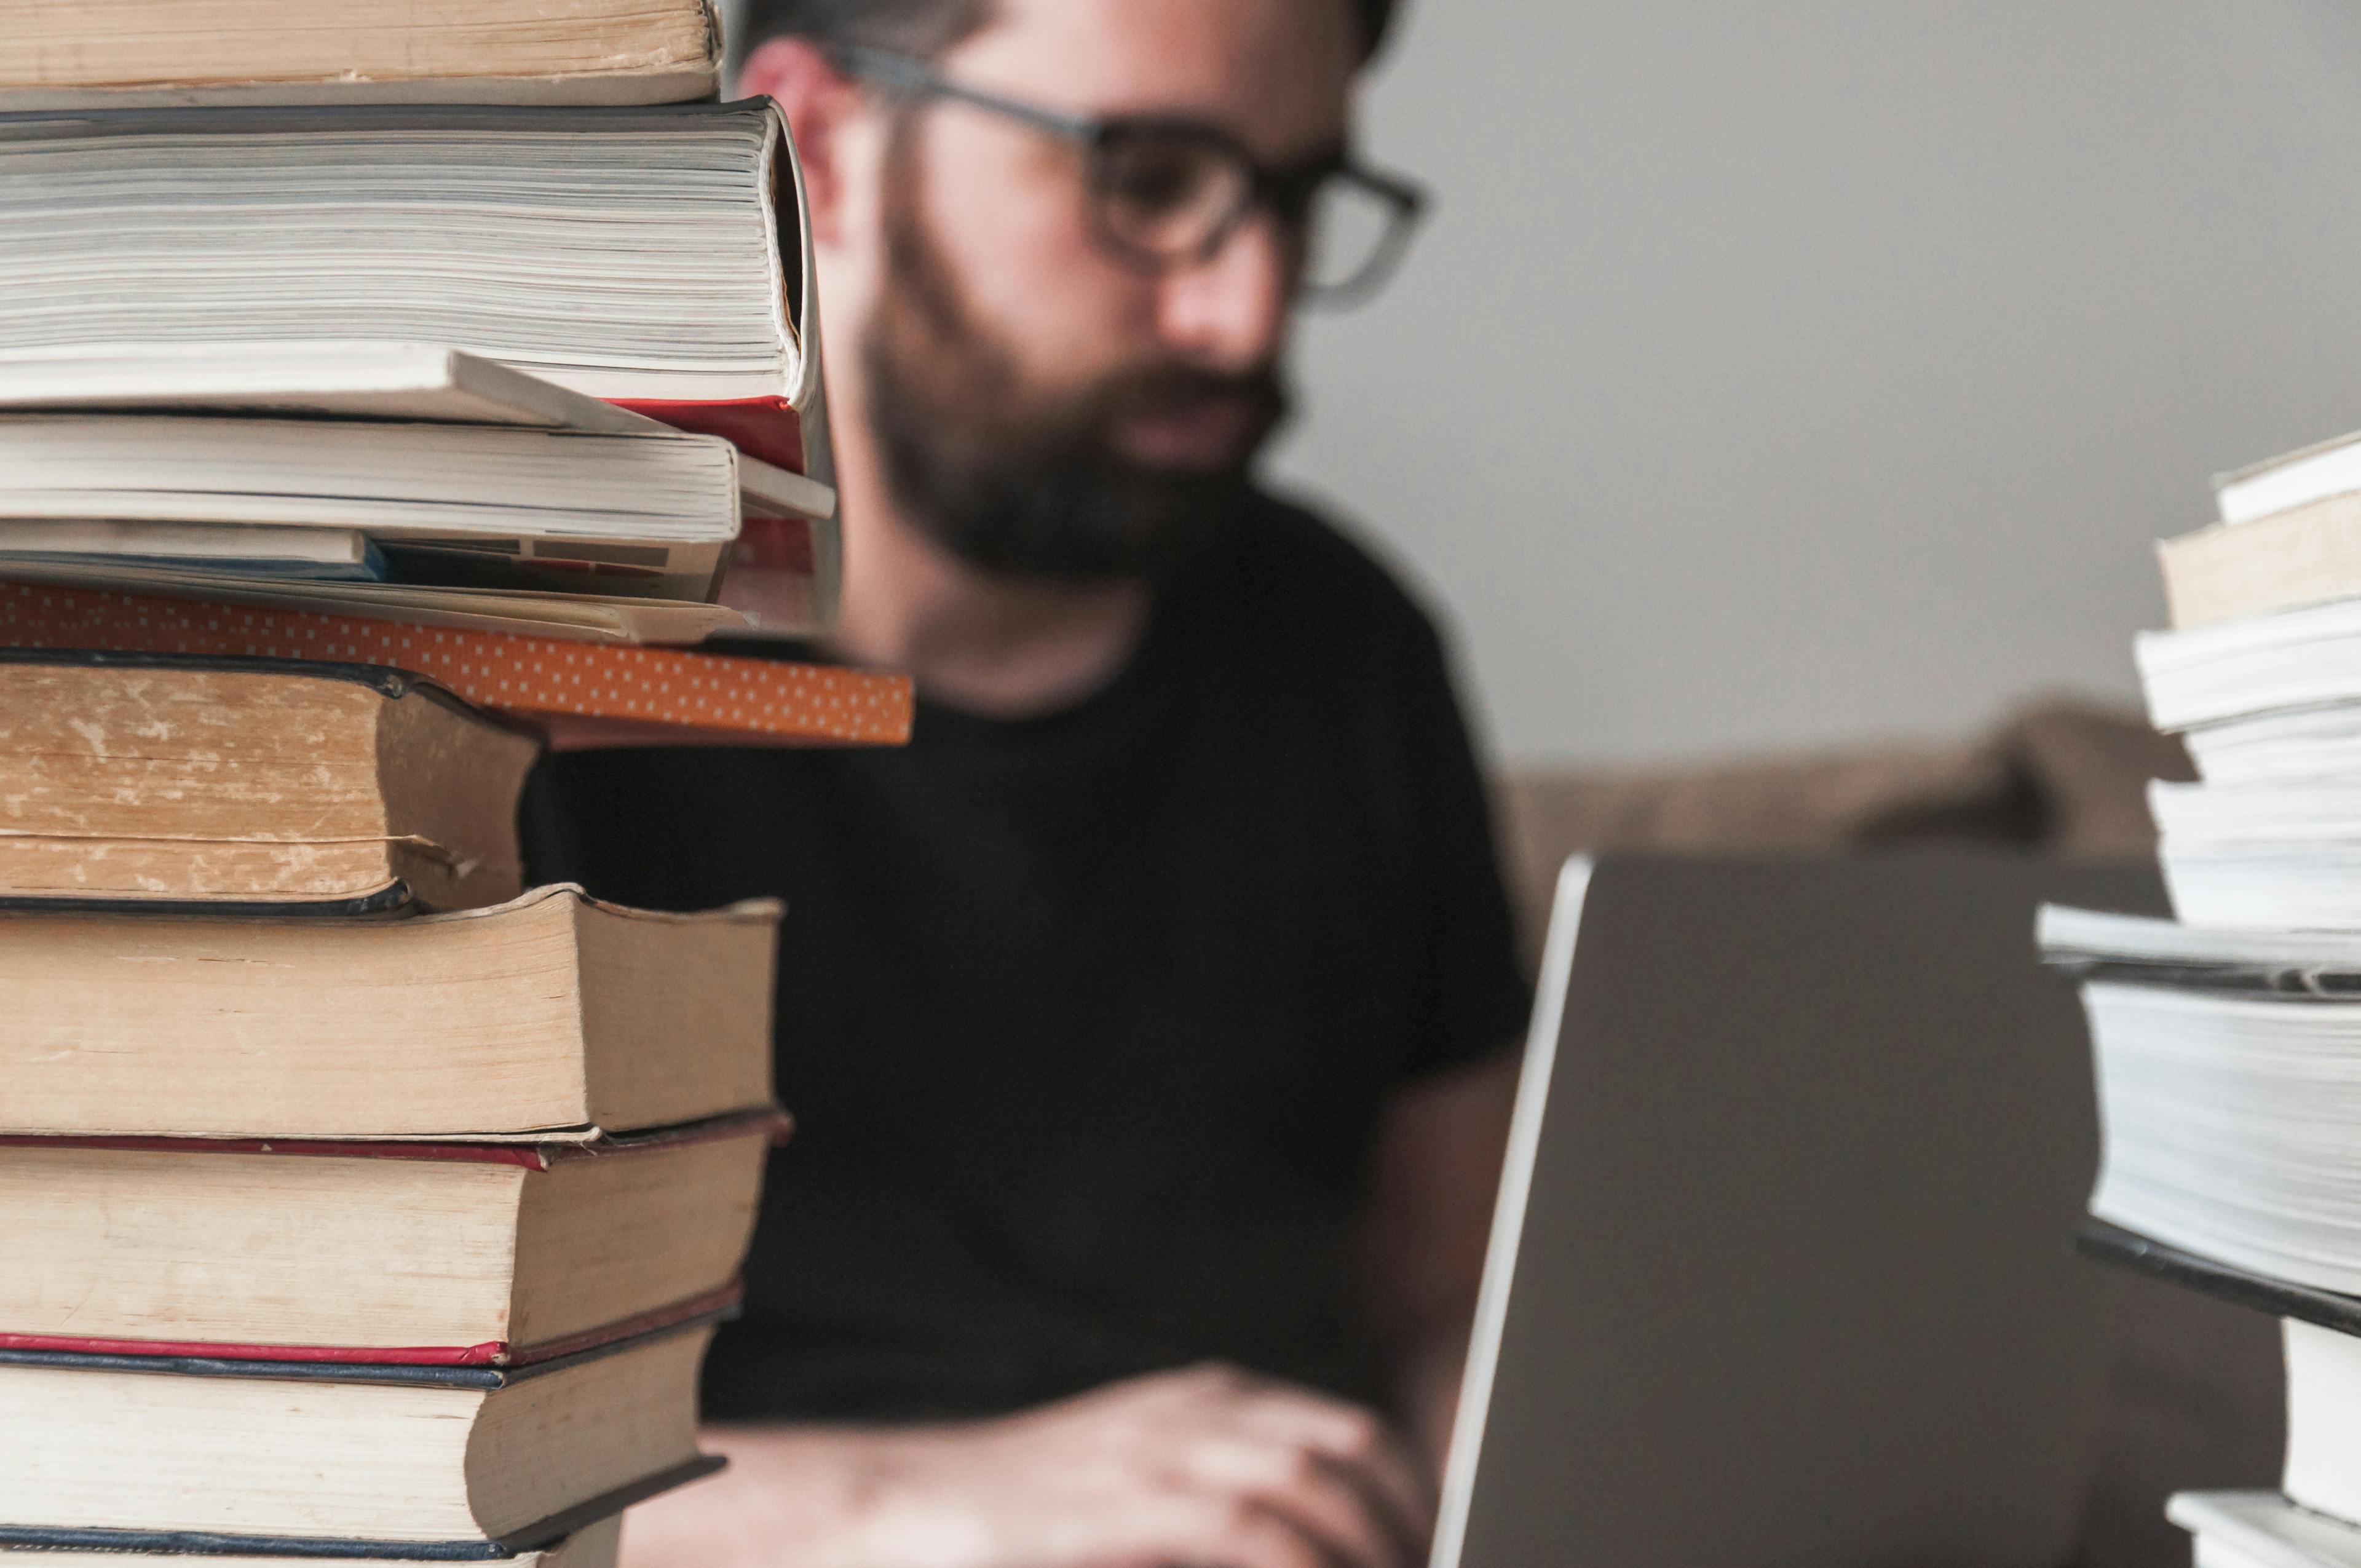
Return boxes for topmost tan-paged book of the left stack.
[0,0,722,109]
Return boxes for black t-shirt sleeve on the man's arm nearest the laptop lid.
[1400,616,1532,1079]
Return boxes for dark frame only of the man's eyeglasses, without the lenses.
[826,45,1428,304]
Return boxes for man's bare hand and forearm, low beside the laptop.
[623,1368,1433,1568]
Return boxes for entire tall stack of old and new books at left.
[0,0,911,1568]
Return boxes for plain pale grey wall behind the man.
[725,0,2361,767]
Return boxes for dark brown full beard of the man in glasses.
[860,121,1287,584]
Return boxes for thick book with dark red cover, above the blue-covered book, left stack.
[0,1112,786,1368]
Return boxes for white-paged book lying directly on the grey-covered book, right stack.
[2148,779,2361,928]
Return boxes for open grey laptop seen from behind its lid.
[1431,855,2162,1568]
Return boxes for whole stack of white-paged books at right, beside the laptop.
[2040,422,2361,1568]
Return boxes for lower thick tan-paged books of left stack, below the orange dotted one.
[0,652,784,1566]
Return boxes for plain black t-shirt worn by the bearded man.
[526,501,1525,1419]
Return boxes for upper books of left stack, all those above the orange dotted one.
[0,0,840,644]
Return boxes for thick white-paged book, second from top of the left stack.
[0,99,826,480]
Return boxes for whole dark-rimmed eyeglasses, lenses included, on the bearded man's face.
[829,45,1426,304]
